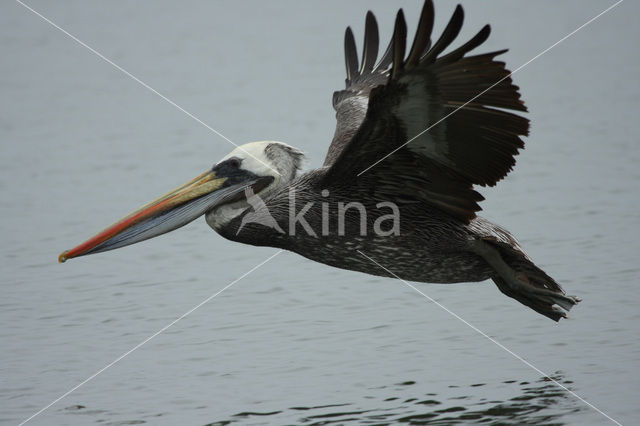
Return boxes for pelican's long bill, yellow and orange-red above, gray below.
[58,171,257,263]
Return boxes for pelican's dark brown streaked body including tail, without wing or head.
[219,169,578,321]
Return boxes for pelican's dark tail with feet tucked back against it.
[472,239,580,321]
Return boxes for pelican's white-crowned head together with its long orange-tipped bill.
[58,141,304,262]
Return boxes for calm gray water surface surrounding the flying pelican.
[0,0,640,425]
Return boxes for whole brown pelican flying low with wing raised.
[59,0,579,321]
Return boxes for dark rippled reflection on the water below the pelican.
[202,373,584,426]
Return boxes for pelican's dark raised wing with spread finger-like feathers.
[322,0,529,221]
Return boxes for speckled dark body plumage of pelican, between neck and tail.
[218,170,492,283]
